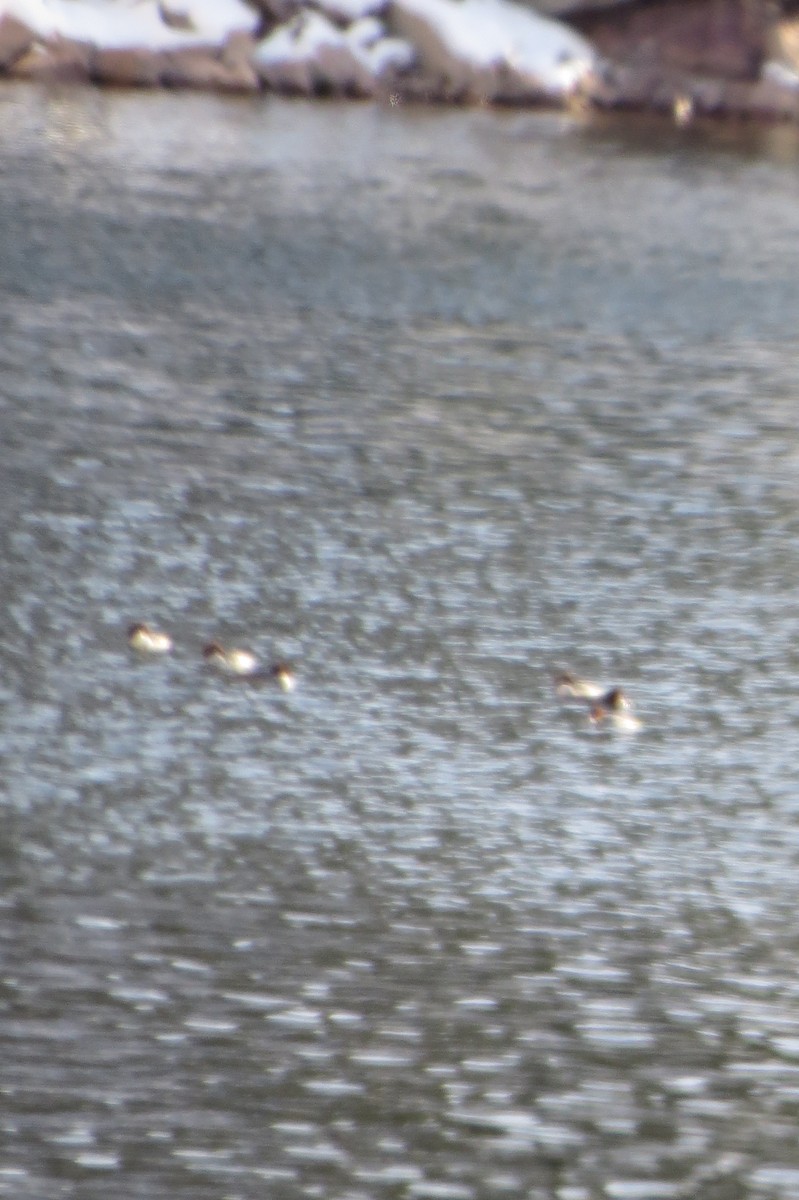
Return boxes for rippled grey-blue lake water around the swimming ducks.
[0,79,799,1200]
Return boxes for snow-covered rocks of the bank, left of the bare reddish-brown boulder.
[0,0,596,102]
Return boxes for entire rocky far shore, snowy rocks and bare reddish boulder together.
[0,0,799,125]
